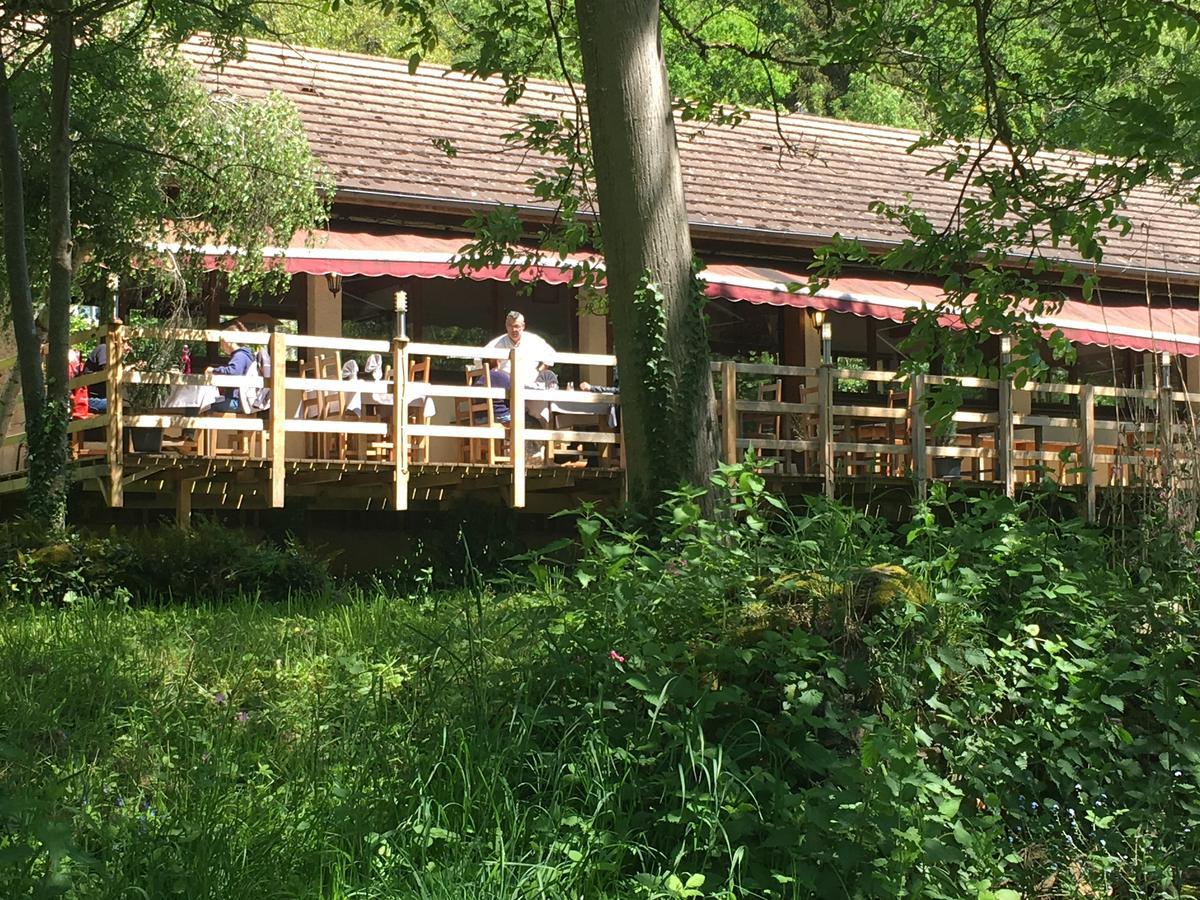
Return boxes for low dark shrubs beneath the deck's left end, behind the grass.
[0,524,331,604]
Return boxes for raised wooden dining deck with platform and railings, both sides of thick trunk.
[0,325,1200,522]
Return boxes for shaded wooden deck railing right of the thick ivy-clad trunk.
[713,354,1200,518]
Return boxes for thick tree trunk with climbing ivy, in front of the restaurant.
[575,0,716,511]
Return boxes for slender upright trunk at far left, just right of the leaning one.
[29,10,74,530]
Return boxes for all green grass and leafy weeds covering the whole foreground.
[0,467,1200,900]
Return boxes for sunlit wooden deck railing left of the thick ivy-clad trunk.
[0,324,620,510]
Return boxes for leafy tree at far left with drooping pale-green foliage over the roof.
[0,0,325,528]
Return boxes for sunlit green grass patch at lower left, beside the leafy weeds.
[0,594,628,900]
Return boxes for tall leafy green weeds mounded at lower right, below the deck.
[518,461,1200,900]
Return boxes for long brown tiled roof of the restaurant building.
[177,42,1200,275]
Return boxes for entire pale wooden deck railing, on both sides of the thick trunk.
[0,324,1200,517]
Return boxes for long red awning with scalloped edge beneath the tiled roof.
[189,229,1200,356]
